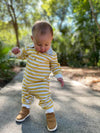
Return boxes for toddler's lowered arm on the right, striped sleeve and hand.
[51,53,64,87]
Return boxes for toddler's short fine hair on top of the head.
[32,21,53,36]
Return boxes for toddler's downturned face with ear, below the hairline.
[31,33,53,53]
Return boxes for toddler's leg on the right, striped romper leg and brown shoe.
[30,82,57,131]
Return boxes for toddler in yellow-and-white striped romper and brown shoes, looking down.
[12,21,64,131]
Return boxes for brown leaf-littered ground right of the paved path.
[62,67,100,91]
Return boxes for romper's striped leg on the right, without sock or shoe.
[29,81,53,110]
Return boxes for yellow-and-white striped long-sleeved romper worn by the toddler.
[18,46,62,110]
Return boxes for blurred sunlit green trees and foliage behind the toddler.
[0,0,100,88]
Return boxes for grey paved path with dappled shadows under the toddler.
[0,71,100,133]
